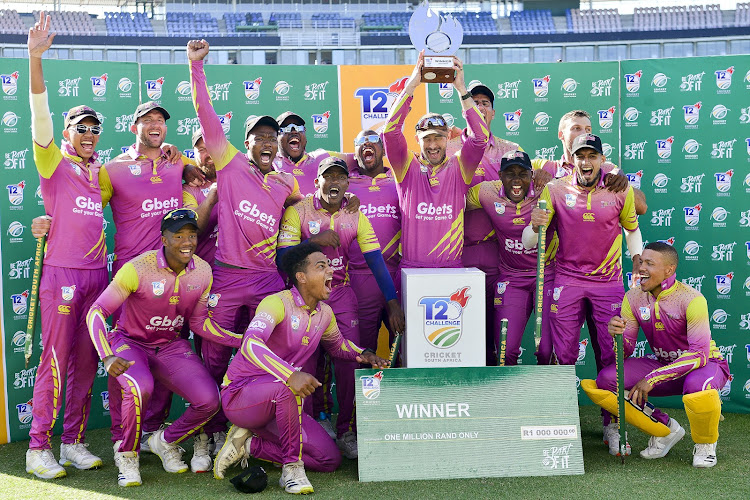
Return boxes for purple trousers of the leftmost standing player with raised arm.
[29,266,107,450]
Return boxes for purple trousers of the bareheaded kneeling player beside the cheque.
[221,375,341,472]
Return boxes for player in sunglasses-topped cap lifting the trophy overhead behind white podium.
[383,53,489,267]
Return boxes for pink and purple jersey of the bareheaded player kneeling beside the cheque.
[224,287,362,386]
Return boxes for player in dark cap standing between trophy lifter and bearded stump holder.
[466,151,554,365]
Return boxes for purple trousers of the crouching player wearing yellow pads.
[596,357,729,425]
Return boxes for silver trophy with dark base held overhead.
[409,1,464,83]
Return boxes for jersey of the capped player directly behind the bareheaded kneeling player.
[279,193,380,288]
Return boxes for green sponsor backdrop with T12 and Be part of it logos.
[0,56,750,446]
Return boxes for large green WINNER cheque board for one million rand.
[356,366,583,481]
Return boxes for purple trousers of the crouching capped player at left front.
[112,333,221,452]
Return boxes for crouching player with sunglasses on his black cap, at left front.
[86,208,242,486]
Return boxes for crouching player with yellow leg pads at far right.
[581,242,729,467]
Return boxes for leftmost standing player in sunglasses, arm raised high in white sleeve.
[26,12,107,479]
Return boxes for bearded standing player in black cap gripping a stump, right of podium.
[523,134,642,366]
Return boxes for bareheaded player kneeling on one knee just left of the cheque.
[214,243,388,494]
